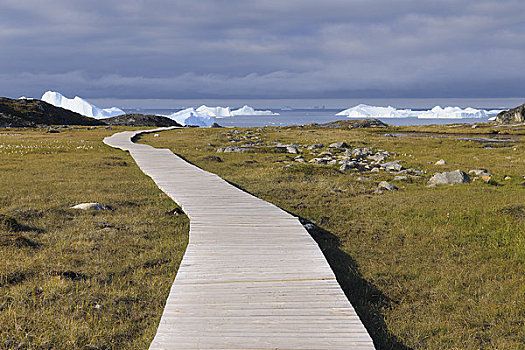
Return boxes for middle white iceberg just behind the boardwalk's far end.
[166,105,279,126]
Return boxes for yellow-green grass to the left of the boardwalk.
[0,128,188,349]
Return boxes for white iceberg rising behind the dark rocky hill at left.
[41,91,126,119]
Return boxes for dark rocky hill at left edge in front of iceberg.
[0,97,105,127]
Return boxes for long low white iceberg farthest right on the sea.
[336,104,501,119]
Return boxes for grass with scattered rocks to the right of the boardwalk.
[142,126,525,349]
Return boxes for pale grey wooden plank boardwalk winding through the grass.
[104,129,374,350]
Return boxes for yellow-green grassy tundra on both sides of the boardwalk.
[0,122,525,349]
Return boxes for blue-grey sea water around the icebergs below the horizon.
[118,98,525,127]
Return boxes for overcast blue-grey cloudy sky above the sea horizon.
[0,0,525,99]
